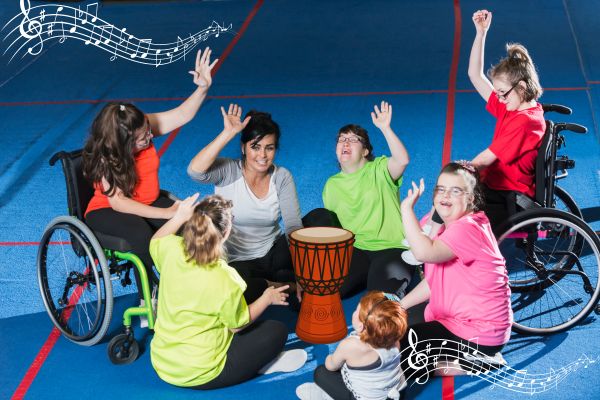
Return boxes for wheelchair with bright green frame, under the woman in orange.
[37,150,172,364]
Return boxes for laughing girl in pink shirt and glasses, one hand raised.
[401,162,512,379]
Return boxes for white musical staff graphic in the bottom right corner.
[401,329,600,395]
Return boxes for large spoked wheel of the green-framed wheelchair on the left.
[37,216,113,346]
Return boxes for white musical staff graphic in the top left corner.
[2,0,234,67]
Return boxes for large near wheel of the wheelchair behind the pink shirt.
[498,209,600,334]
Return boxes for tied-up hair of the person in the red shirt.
[487,43,543,101]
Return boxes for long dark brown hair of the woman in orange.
[82,103,146,197]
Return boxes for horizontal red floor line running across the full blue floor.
[0,86,600,107]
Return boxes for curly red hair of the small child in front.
[358,291,408,349]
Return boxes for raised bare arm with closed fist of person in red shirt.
[469,10,494,101]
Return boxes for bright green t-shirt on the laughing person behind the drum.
[323,156,406,250]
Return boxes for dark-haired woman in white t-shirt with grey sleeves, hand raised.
[188,104,302,301]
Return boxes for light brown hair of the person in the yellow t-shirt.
[183,195,233,265]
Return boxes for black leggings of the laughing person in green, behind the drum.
[302,208,415,298]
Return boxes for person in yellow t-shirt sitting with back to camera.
[150,194,306,389]
